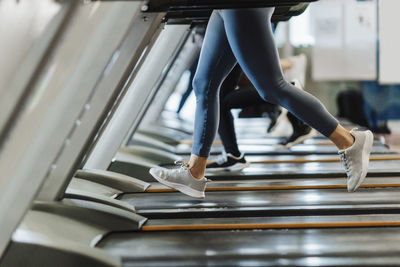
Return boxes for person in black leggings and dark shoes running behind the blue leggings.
[206,60,316,172]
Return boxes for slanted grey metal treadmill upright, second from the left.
[38,3,163,203]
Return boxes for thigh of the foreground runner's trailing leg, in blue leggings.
[222,8,283,93]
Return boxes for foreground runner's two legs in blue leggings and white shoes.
[150,7,373,198]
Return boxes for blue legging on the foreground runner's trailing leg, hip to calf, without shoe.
[221,8,338,136]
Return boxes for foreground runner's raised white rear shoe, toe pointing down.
[339,129,374,192]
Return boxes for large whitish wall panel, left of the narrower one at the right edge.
[310,0,378,81]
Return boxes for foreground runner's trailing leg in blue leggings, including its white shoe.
[221,8,373,191]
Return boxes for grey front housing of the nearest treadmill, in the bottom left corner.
[0,204,142,267]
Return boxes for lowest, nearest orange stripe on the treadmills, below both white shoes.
[141,221,400,231]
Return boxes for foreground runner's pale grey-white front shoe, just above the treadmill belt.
[149,165,207,198]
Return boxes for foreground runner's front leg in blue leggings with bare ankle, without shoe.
[189,11,236,178]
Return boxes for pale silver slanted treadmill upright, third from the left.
[84,26,191,170]
